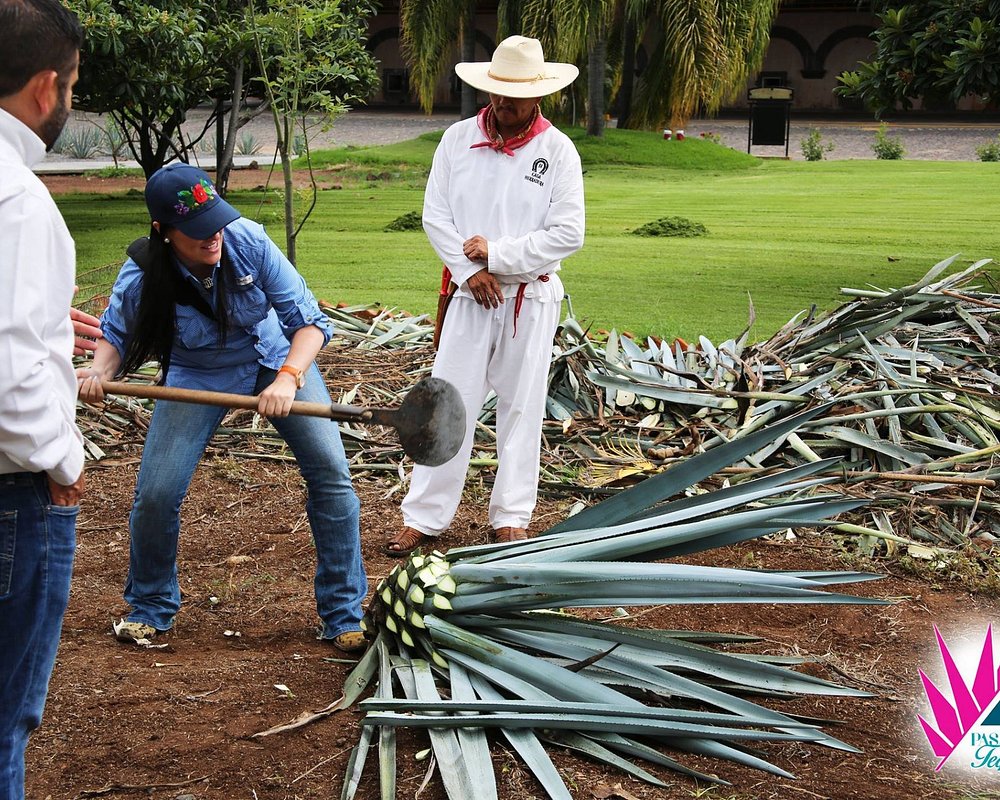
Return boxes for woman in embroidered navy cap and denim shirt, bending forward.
[77,163,367,652]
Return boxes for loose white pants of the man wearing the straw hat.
[402,297,561,536]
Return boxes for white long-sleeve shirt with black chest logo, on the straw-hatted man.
[423,117,585,302]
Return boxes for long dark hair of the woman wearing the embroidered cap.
[119,226,231,383]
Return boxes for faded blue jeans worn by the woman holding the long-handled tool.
[125,364,368,638]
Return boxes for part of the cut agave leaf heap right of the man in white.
[549,258,1000,558]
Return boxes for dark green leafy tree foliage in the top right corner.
[835,0,1000,115]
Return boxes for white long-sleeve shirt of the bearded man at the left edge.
[0,109,83,486]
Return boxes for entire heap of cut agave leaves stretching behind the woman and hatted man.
[78,258,1000,564]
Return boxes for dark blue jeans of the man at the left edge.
[0,472,80,800]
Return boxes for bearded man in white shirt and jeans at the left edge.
[0,0,83,800]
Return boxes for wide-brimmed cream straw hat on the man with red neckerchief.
[455,36,580,97]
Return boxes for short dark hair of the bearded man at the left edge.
[0,0,83,97]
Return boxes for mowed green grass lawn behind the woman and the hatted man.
[64,131,1000,340]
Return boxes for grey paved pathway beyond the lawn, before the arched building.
[38,111,1000,172]
